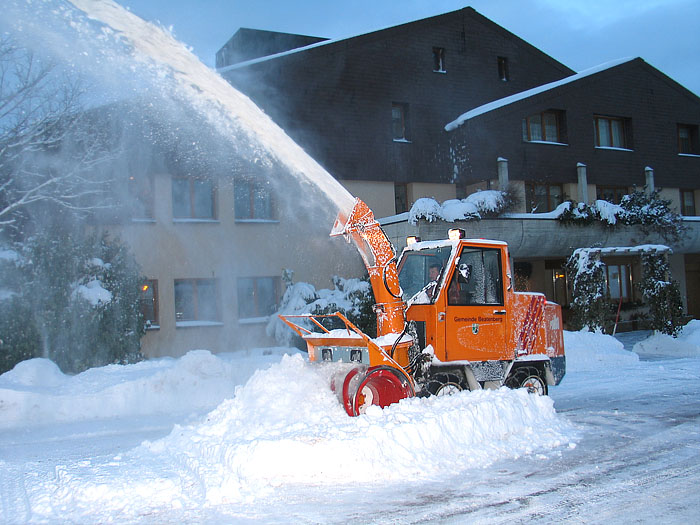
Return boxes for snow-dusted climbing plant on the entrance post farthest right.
[639,251,683,337]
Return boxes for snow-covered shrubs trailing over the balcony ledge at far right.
[556,190,684,242]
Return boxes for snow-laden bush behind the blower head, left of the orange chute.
[267,272,377,346]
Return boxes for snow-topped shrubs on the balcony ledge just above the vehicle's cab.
[408,190,505,224]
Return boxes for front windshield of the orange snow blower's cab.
[399,246,452,304]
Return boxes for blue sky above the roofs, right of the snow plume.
[117,0,700,95]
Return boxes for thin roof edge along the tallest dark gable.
[217,7,573,73]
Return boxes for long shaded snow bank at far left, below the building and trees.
[0,348,295,429]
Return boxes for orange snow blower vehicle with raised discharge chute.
[280,199,566,416]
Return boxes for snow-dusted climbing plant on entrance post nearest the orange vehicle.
[566,248,613,331]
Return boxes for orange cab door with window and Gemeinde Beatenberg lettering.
[438,246,512,361]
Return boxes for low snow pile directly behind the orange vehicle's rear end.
[564,330,639,370]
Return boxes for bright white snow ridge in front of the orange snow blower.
[34,355,578,518]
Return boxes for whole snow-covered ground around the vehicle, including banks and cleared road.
[0,321,700,523]
